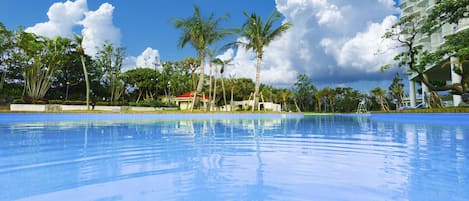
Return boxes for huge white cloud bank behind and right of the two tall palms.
[219,0,397,86]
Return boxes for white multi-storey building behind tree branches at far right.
[400,0,469,107]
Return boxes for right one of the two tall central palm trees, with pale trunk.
[237,10,292,111]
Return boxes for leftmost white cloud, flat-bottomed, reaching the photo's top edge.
[25,0,88,38]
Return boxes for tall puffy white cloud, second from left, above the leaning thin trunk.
[80,3,121,56]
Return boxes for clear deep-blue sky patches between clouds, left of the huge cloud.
[0,0,275,60]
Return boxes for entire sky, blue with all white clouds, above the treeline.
[0,0,400,91]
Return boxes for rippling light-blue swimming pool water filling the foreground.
[0,114,469,201]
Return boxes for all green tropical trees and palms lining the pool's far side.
[0,0,469,112]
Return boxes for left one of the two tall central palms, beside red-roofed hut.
[172,5,229,110]
